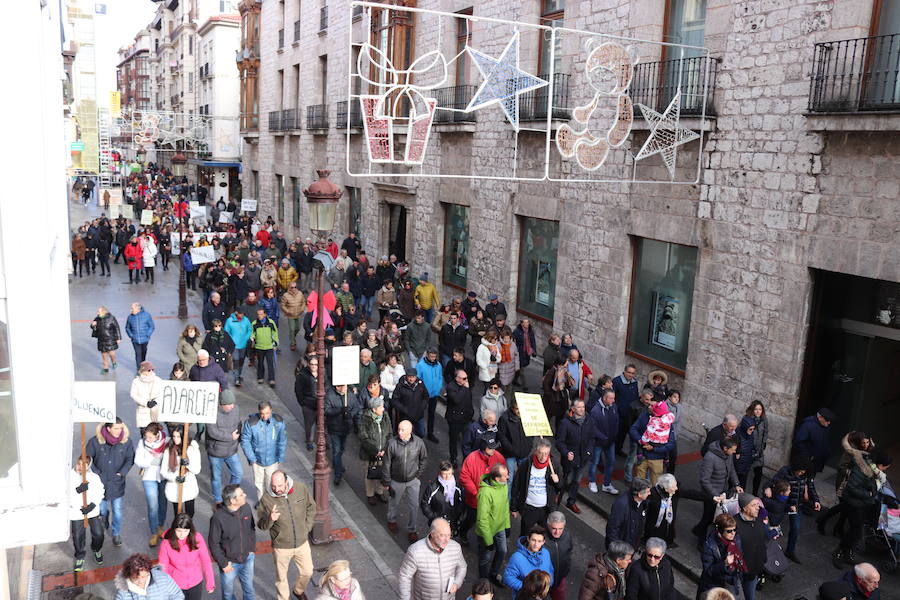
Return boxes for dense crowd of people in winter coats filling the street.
[71,166,900,600]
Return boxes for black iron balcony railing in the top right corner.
[809,33,900,112]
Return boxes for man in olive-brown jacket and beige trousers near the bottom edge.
[256,470,316,600]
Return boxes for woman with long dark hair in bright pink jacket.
[159,513,216,600]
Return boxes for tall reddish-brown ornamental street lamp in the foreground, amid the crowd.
[303,169,343,544]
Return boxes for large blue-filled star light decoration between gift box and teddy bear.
[466,31,549,129]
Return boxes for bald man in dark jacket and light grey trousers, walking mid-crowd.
[381,421,428,543]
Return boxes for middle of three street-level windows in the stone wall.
[516,217,559,323]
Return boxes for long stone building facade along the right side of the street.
[241,0,900,466]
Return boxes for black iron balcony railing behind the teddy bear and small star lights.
[628,56,719,116]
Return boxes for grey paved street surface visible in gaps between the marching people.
[35,207,900,599]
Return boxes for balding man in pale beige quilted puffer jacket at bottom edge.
[397,518,466,600]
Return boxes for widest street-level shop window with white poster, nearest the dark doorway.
[625,238,697,375]
